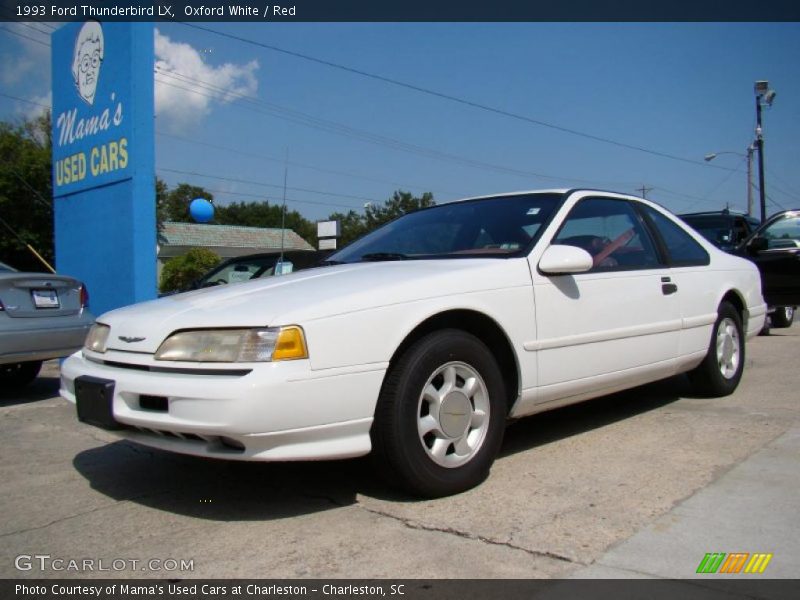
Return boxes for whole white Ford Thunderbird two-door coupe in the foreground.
[61,190,766,497]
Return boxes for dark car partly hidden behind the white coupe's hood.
[184,250,331,291]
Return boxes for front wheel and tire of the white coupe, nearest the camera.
[371,329,507,498]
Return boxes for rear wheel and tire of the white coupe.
[689,302,745,398]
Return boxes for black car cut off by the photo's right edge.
[734,210,800,327]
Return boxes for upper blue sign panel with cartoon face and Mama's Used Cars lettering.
[53,21,132,196]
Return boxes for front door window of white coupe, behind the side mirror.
[553,198,660,271]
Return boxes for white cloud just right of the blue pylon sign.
[155,29,259,130]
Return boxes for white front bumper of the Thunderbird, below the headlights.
[60,352,388,461]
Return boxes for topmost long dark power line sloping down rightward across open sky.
[181,23,728,170]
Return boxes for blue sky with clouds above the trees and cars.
[0,23,800,220]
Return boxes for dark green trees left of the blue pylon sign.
[0,111,54,271]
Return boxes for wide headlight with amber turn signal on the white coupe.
[155,325,308,362]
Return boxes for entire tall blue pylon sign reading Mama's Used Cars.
[52,21,156,315]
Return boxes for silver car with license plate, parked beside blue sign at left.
[0,263,94,389]
